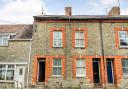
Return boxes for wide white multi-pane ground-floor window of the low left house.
[0,64,14,80]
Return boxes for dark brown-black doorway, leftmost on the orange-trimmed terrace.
[38,59,45,82]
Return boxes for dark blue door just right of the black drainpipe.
[106,58,114,83]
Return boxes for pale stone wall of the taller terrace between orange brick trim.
[30,22,128,88]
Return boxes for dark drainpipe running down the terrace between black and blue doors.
[99,18,106,89]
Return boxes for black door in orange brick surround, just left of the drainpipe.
[93,58,100,84]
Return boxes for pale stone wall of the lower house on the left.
[0,40,30,86]
